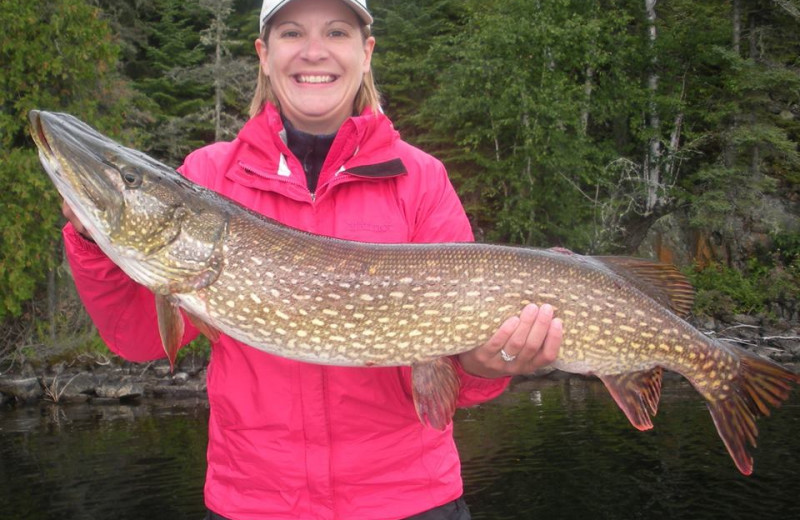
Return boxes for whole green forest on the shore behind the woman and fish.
[0,0,800,363]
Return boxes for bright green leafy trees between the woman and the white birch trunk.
[406,0,642,250]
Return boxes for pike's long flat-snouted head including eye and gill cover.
[29,110,225,288]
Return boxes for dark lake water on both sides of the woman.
[0,378,800,520]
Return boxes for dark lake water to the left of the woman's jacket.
[0,403,207,520]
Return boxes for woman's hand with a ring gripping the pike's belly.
[459,304,563,378]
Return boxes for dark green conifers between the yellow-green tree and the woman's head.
[93,0,258,166]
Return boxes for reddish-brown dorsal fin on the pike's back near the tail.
[592,256,694,318]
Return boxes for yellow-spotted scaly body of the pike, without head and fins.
[192,211,735,386]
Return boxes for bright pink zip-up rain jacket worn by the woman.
[64,106,508,520]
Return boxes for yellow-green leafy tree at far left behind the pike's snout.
[0,0,130,319]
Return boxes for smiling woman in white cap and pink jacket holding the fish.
[64,0,561,520]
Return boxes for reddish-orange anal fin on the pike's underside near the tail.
[600,367,662,430]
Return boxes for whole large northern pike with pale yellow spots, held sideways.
[29,111,800,474]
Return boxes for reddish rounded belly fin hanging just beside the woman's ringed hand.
[411,358,459,430]
